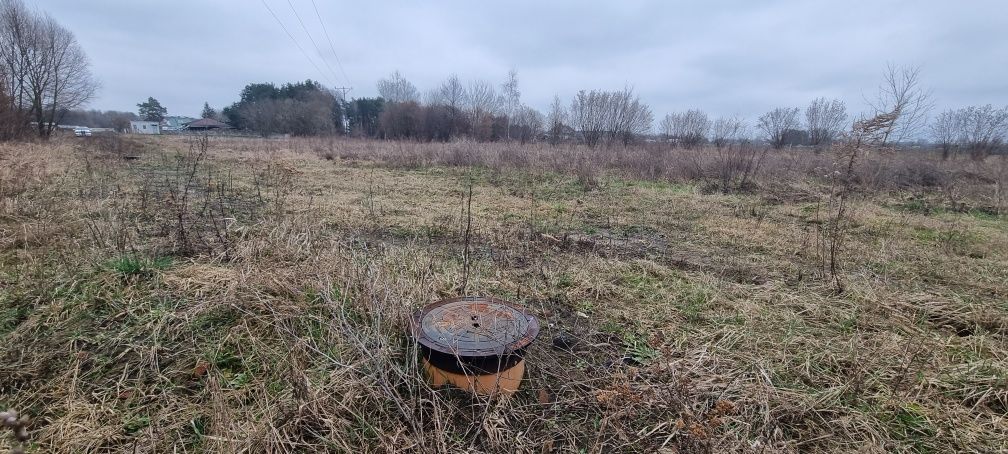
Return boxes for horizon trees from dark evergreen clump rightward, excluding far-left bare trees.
[187,67,1008,157]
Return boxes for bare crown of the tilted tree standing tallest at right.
[869,65,932,145]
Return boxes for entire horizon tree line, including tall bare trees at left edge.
[0,0,1008,158]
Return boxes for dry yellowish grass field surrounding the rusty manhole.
[0,133,1008,453]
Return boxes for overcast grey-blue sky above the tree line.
[27,0,1008,118]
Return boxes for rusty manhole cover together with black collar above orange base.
[412,297,539,374]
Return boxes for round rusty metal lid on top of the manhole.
[413,297,539,357]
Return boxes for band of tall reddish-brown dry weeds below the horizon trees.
[200,138,1008,213]
